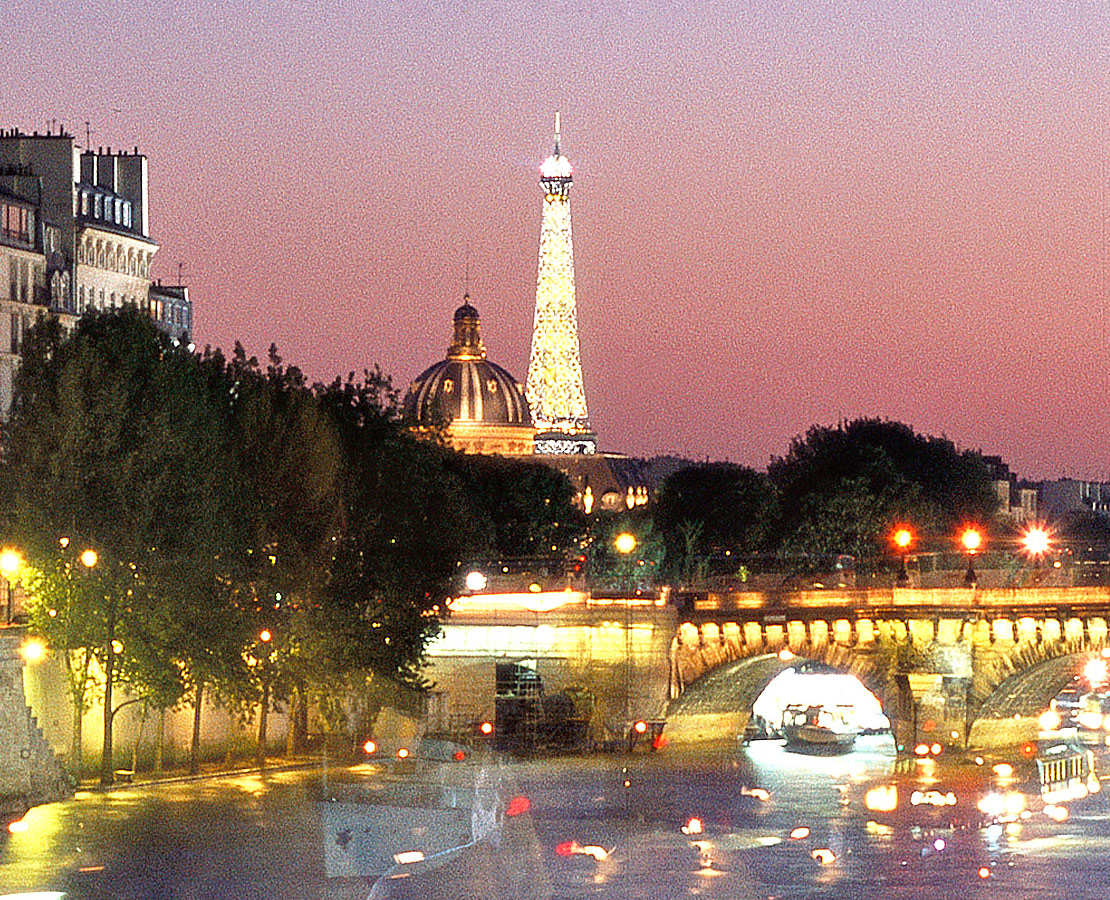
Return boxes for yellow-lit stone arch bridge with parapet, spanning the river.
[668,587,1110,747]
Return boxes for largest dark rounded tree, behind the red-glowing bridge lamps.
[768,418,998,558]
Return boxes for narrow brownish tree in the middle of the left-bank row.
[214,344,342,766]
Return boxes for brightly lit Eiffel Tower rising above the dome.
[524,112,597,454]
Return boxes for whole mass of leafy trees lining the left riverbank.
[0,309,508,780]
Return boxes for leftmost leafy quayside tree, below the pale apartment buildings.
[3,307,247,783]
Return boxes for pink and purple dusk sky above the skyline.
[8,0,1110,481]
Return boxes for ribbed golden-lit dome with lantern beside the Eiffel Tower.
[404,294,535,456]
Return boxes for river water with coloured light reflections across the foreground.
[0,737,1110,900]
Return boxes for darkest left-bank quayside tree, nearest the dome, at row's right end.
[310,371,491,736]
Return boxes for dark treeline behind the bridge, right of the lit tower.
[654,418,998,580]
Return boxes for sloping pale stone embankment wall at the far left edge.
[0,627,73,810]
